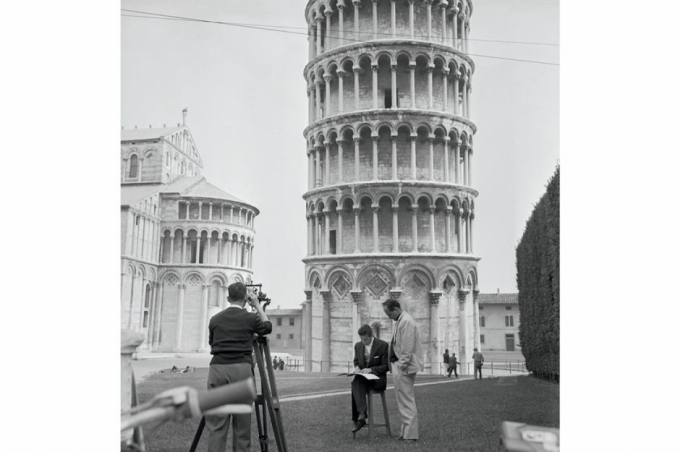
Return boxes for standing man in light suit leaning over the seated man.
[382,299,423,443]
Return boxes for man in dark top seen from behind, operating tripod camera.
[205,282,272,452]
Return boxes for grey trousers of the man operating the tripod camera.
[205,363,253,452]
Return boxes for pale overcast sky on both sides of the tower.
[121,0,559,307]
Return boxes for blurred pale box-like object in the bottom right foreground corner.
[500,421,560,452]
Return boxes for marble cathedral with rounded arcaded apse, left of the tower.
[120,124,259,352]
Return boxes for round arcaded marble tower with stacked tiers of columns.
[303,0,479,374]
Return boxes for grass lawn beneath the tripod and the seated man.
[138,369,559,452]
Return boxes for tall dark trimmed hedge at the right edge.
[516,167,560,379]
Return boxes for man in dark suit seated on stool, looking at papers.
[352,325,389,432]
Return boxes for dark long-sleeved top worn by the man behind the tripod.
[208,307,272,364]
